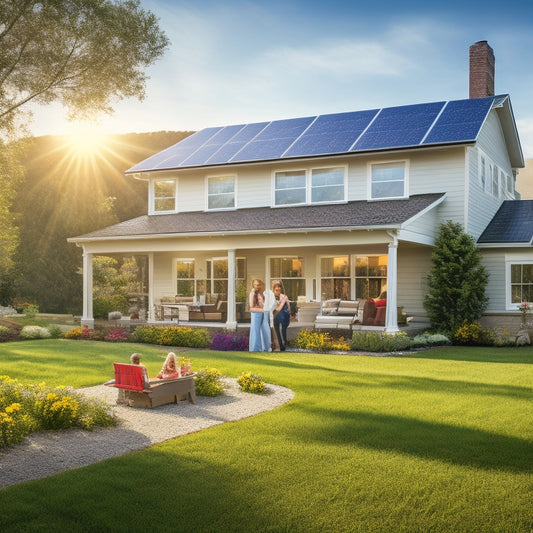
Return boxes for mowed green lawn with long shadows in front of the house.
[0,340,533,533]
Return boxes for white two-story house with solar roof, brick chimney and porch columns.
[70,41,533,331]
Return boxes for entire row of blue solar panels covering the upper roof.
[128,97,494,172]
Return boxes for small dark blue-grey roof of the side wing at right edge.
[477,200,533,246]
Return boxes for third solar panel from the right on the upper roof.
[283,109,378,157]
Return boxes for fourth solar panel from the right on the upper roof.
[231,117,315,162]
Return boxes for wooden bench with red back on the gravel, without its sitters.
[108,363,196,408]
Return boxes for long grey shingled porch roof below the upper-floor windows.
[68,193,445,242]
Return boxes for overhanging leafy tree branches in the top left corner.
[0,0,169,132]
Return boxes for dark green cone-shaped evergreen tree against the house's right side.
[424,221,488,332]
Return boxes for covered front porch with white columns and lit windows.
[76,225,430,332]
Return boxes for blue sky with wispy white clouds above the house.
[32,0,533,158]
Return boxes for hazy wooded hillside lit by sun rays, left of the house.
[12,131,191,314]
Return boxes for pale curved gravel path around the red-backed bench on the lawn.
[0,378,294,488]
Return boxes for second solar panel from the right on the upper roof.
[351,102,444,151]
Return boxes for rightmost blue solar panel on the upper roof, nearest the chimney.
[423,96,494,144]
